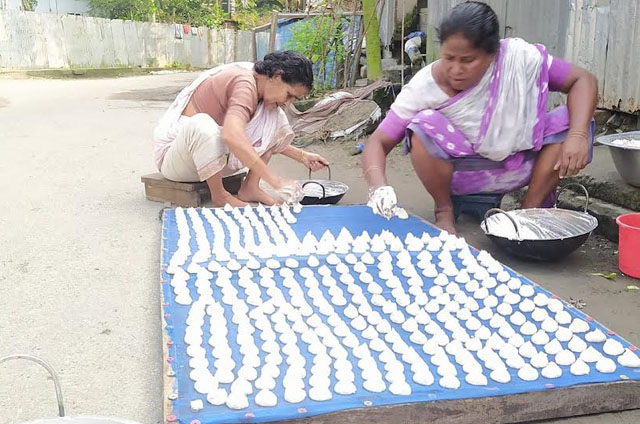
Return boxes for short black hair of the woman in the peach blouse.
[254,50,313,90]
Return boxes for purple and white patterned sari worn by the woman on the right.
[380,38,593,195]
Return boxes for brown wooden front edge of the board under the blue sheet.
[279,381,640,424]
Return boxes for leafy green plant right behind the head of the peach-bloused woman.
[285,16,348,93]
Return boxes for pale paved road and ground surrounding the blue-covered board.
[0,74,640,424]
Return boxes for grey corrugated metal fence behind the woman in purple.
[427,0,640,113]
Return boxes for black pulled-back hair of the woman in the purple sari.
[438,1,500,54]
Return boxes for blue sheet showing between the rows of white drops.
[162,206,640,424]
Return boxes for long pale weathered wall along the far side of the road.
[0,10,254,69]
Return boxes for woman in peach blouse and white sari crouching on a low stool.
[153,51,328,206]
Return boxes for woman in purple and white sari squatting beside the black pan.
[362,1,597,234]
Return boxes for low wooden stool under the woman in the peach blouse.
[140,172,247,208]
